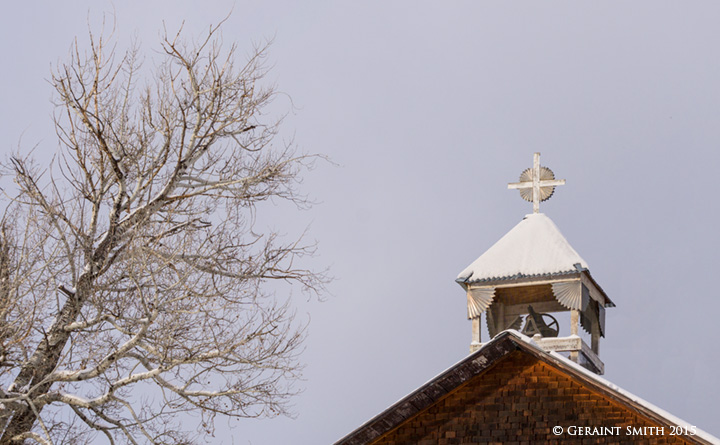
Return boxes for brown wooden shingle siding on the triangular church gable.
[370,351,695,445]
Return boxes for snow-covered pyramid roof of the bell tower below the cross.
[456,213,588,284]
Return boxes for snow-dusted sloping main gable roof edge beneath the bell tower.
[335,330,720,445]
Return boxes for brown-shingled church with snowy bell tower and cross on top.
[336,153,720,445]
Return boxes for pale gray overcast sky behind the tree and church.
[0,0,720,444]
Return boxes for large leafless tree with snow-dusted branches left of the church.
[0,20,325,444]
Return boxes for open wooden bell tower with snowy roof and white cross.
[456,153,615,374]
